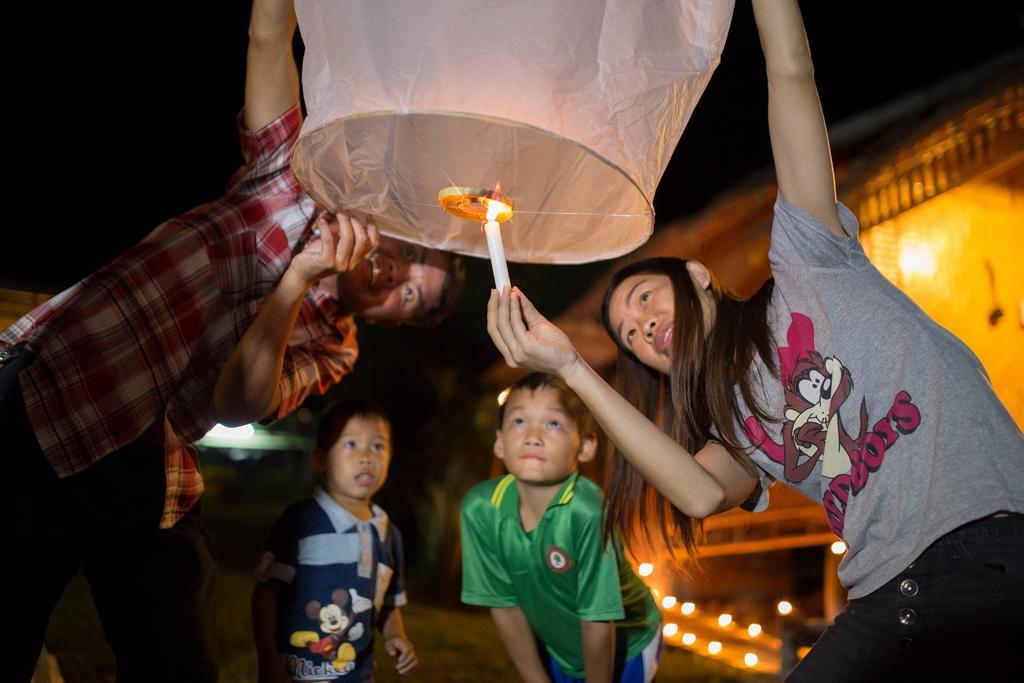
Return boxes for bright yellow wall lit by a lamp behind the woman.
[861,156,1024,426]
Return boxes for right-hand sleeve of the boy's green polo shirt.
[575,513,626,622]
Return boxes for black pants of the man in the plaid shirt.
[0,353,217,683]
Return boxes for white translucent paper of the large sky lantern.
[292,0,733,263]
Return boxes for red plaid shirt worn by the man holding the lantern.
[0,106,357,527]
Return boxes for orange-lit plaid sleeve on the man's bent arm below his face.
[274,317,359,420]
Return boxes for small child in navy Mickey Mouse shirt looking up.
[253,399,417,683]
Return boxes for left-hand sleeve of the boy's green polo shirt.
[460,494,519,607]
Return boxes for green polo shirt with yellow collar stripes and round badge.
[462,473,660,678]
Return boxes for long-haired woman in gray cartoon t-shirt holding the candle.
[487,0,1024,681]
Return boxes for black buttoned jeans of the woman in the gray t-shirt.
[785,514,1024,683]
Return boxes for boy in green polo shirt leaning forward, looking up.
[462,373,662,683]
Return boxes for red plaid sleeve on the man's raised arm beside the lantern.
[227,104,302,195]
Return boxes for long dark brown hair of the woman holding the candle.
[601,257,777,553]
